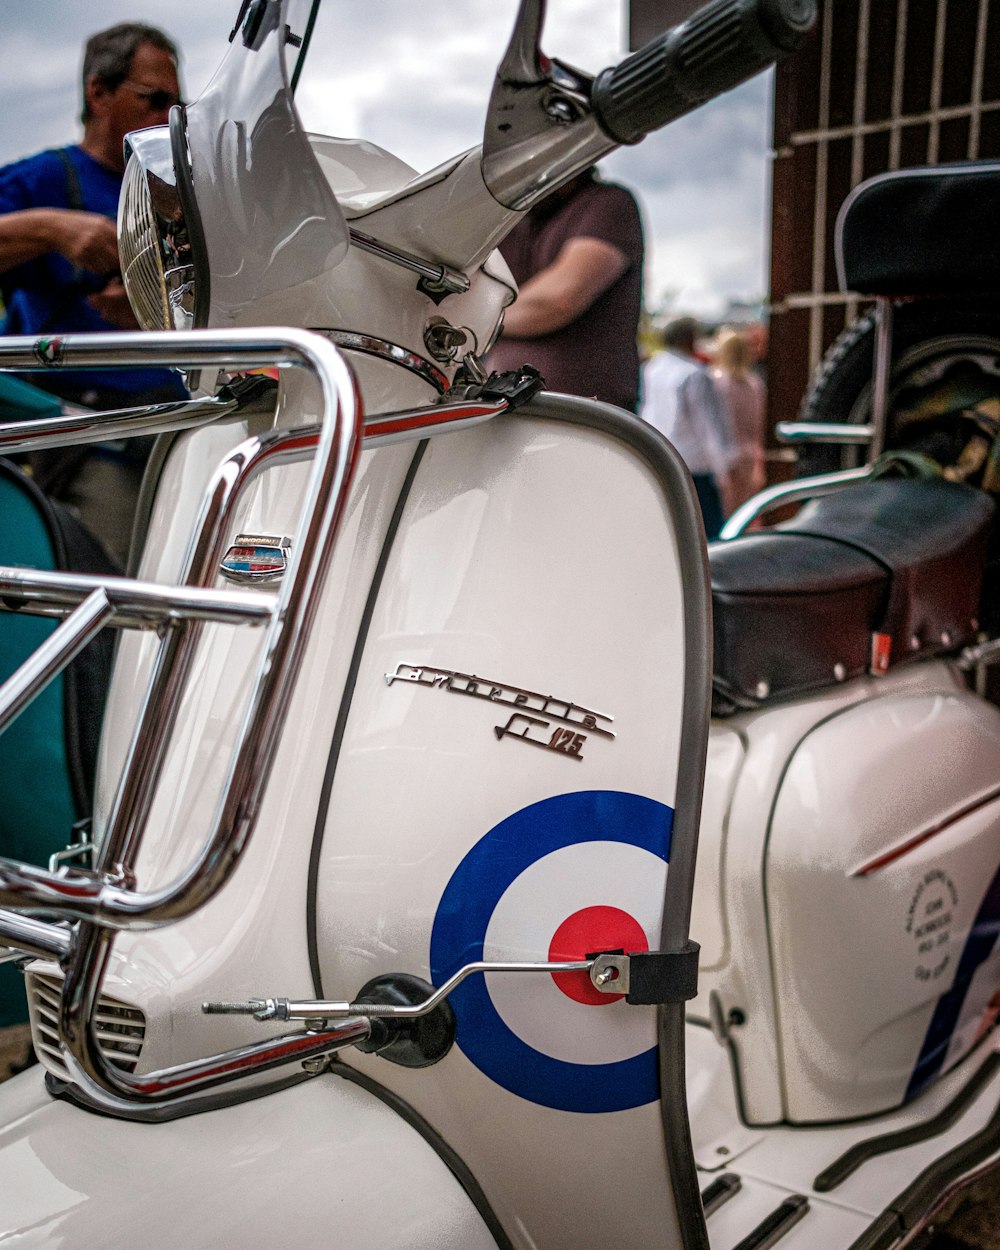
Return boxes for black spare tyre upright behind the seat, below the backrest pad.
[796,299,1000,476]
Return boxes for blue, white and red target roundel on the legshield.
[430,790,674,1114]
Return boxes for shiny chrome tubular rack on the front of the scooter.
[0,329,508,1116]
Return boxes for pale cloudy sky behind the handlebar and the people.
[0,0,771,316]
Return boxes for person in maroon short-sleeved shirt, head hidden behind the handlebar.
[489,168,643,411]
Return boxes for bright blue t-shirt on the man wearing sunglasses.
[0,146,186,404]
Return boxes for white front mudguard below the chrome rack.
[0,1069,496,1250]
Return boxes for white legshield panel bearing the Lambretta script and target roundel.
[316,405,706,1250]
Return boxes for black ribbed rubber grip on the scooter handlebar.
[590,0,816,144]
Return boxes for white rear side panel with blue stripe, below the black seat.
[766,690,1000,1121]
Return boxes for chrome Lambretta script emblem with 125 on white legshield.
[385,664,615,760]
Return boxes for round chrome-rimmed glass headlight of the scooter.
[118,126,196,330]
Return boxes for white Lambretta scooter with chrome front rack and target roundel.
[0,0,1000,1250]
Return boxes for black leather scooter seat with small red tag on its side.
[709,478,994,715]
